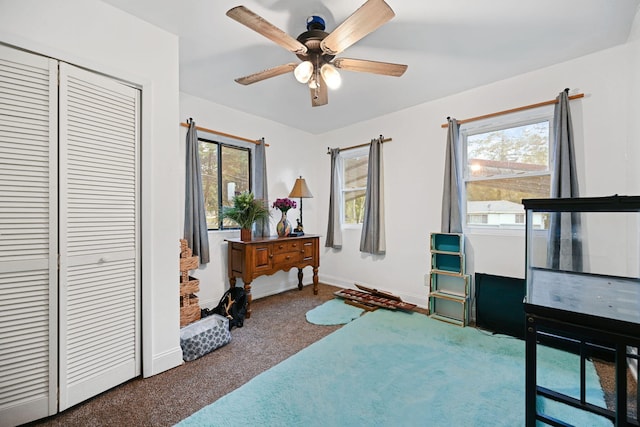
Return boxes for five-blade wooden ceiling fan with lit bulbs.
[222,0,407,107]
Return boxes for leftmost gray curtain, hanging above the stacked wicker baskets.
[184,119,209,264]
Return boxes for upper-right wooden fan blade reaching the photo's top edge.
[320,0,396,55]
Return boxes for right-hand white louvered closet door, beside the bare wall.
[59,63,140,410]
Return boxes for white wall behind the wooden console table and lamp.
[180,92,326,310]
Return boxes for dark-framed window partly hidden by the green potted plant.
[198,138,251,230]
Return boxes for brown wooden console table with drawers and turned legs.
[225,235,320,318]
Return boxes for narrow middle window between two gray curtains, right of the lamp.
[341,147,369,224]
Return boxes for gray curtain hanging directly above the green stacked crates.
[440,117,462,233]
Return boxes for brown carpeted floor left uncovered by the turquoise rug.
[26,284,635,427]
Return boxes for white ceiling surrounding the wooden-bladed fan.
[103,0,640,134]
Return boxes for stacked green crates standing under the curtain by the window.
[429,233,470,326]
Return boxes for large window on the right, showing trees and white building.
[460,108,553,229]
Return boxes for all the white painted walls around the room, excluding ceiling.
[0,0,640,384]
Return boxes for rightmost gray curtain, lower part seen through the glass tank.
[547,89,582,271]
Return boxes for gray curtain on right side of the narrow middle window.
[360,137,386,255]
